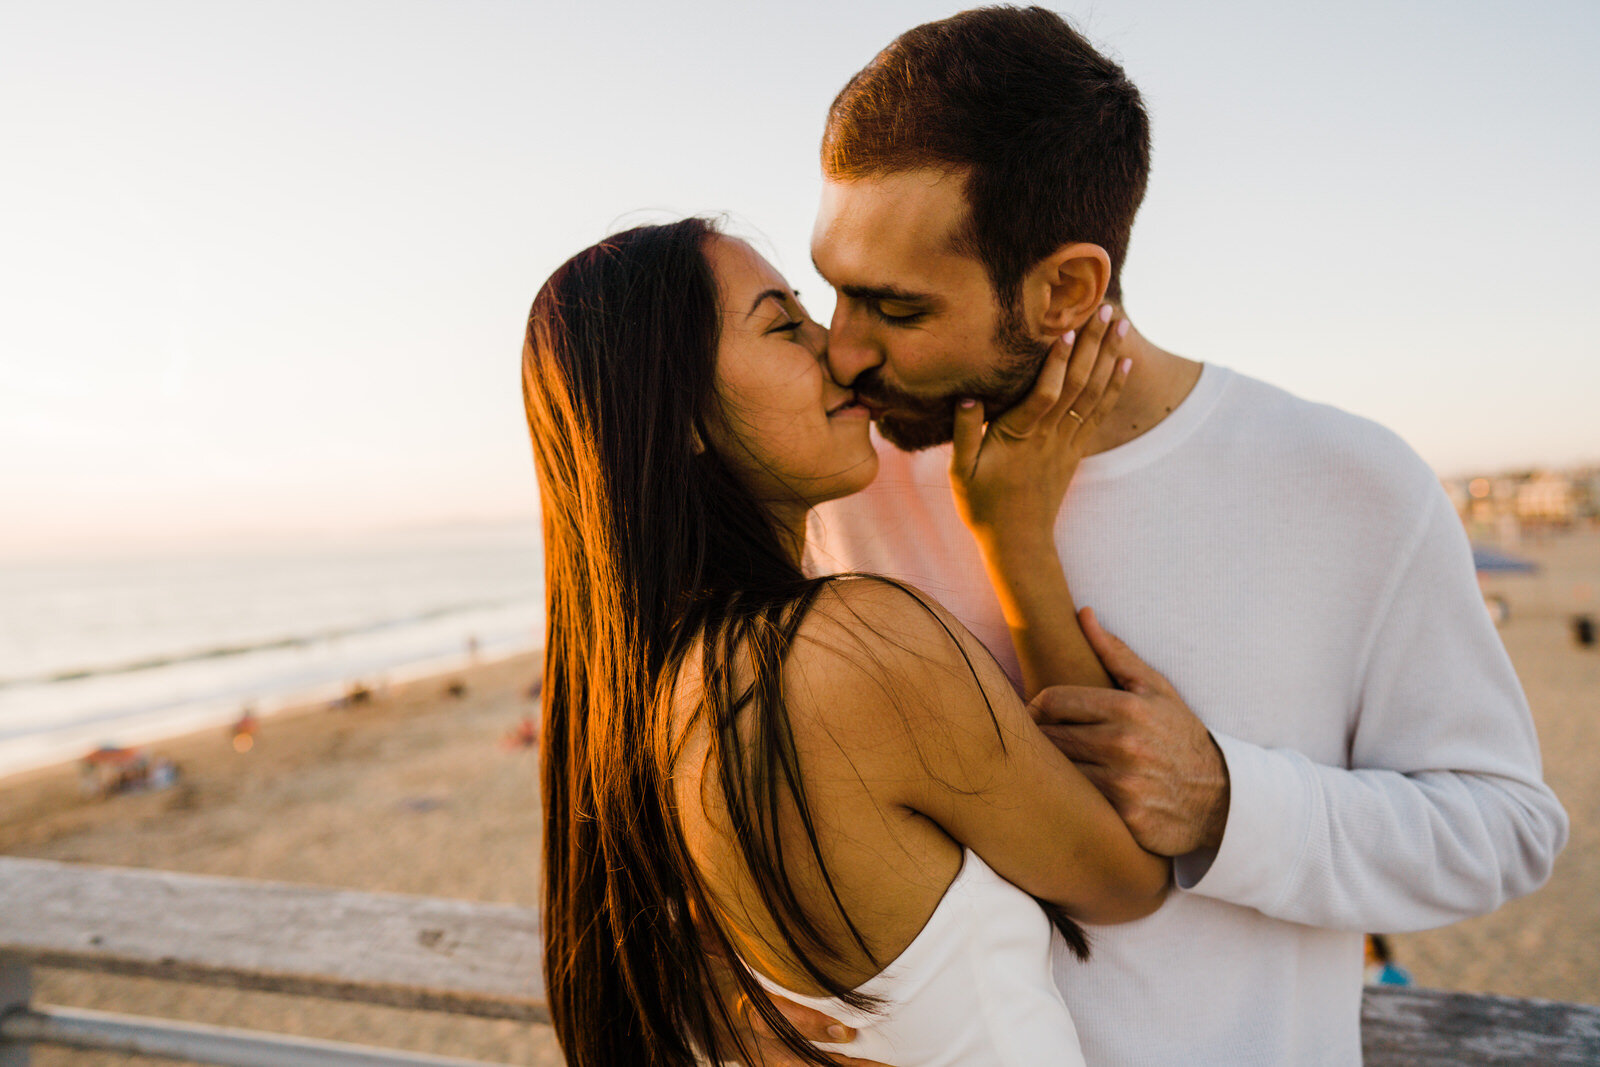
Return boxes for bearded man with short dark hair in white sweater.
[745,8,1566,1067]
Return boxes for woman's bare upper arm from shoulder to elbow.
[786,579,1170,923]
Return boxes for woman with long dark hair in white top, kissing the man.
[523,219,1168,1067]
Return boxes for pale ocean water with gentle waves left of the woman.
[0,523,544,774]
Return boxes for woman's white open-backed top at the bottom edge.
[752,849,1083,1067]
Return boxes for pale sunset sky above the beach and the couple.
[0,0,1600,555]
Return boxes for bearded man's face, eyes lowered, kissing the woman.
[811,170,1050,450]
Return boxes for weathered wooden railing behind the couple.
[0,857,1600,1067]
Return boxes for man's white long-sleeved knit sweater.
[811,366,1566,1067]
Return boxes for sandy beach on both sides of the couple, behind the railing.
[0,533,1600,1067]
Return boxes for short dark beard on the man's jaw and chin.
[853,306,1050,453]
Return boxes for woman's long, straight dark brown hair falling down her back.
[523,218,1082,1067]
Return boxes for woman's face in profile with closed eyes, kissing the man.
[706,237,878,506]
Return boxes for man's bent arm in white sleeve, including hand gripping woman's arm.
[1035,493,1566,931]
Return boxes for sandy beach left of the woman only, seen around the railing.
[0,656,562,1067]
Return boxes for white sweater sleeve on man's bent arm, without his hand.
[1176,491,1566,931]
